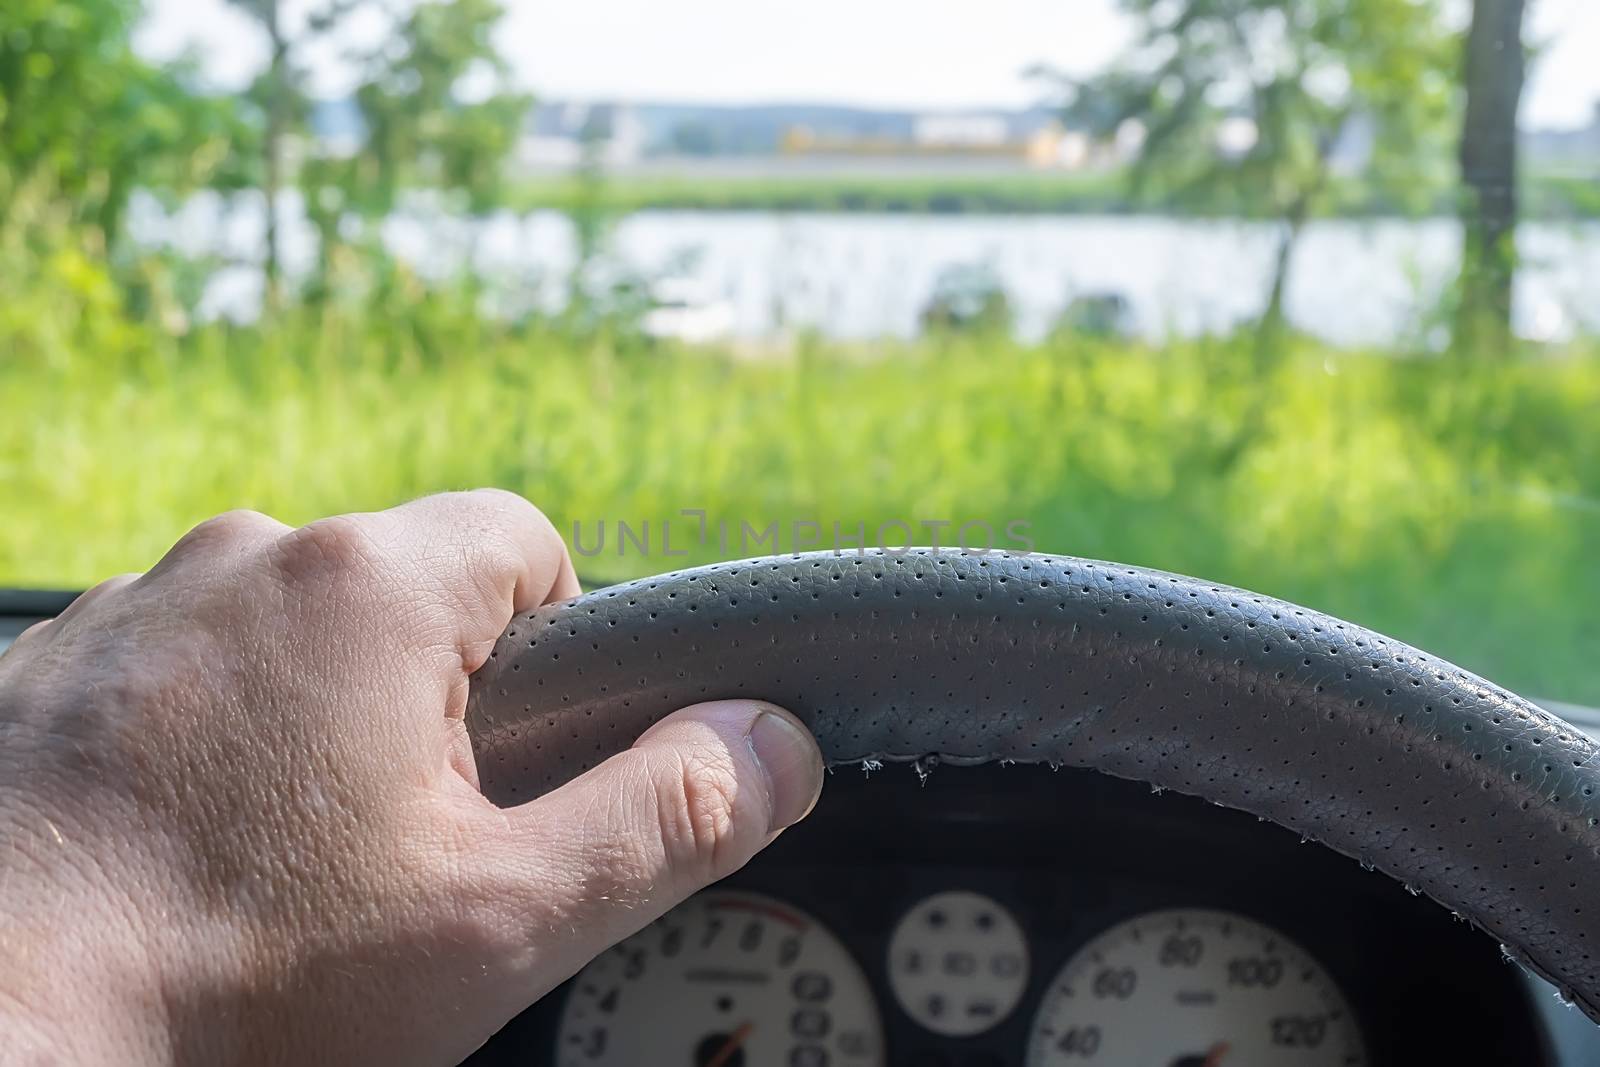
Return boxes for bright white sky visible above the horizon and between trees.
[136,0,1600,128]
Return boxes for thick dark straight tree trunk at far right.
[1454,0,1526,355]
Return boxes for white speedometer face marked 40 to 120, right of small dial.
[1027,910,1366,1067]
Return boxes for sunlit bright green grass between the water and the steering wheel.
[9,194,1600,704]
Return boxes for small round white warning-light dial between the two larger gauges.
[890,893,1027,1037]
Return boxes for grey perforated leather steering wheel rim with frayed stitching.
[467,549,1600,1022]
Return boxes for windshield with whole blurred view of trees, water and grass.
[0,0,1600,716]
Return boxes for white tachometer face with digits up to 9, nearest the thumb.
[555,891,883,1067]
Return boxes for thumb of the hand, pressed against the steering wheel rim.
[467,701,822,997]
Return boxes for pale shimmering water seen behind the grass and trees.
[131,187,1600,344]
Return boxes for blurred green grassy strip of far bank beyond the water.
[507,164,1600,219]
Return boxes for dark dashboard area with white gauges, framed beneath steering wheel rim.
[470,765,1600,1067]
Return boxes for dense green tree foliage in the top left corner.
[0,0,251,248]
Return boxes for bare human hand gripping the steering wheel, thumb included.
[0,491,822,1064]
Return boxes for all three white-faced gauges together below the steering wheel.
[555,889,1366,1067]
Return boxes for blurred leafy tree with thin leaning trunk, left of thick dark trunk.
[1067,0,1453,358]
